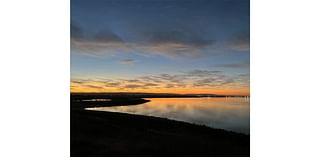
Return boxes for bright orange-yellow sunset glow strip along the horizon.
[71,73,250,96]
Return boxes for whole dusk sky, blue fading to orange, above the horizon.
[70,0,250,95]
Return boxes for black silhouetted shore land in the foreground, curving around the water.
[71,93,250,157]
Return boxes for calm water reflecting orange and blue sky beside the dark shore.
[87,98,250,134]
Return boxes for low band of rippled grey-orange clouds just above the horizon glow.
[72,69,250,90]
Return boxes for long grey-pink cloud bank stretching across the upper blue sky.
[71,22,215,57]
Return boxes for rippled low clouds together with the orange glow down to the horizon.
[71,70,250,95]
